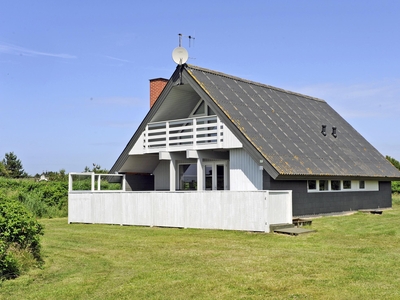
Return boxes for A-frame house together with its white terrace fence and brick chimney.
[69,64,400,232]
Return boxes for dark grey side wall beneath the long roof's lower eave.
[263,171,392,216]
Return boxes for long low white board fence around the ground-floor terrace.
[68,191,292,232]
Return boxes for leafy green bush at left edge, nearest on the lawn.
[0,195,43,279]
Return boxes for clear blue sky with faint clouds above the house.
[0,0,400,175]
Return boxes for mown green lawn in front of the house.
[0,198,400,299]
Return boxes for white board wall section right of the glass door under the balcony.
[229,149,263,191]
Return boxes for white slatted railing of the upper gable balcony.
[143,116,224,153]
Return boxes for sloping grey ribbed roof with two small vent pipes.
[183,65,400,179]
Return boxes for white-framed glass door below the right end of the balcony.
[203,161,229,190]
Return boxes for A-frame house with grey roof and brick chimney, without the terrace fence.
[111,64,400,216]
